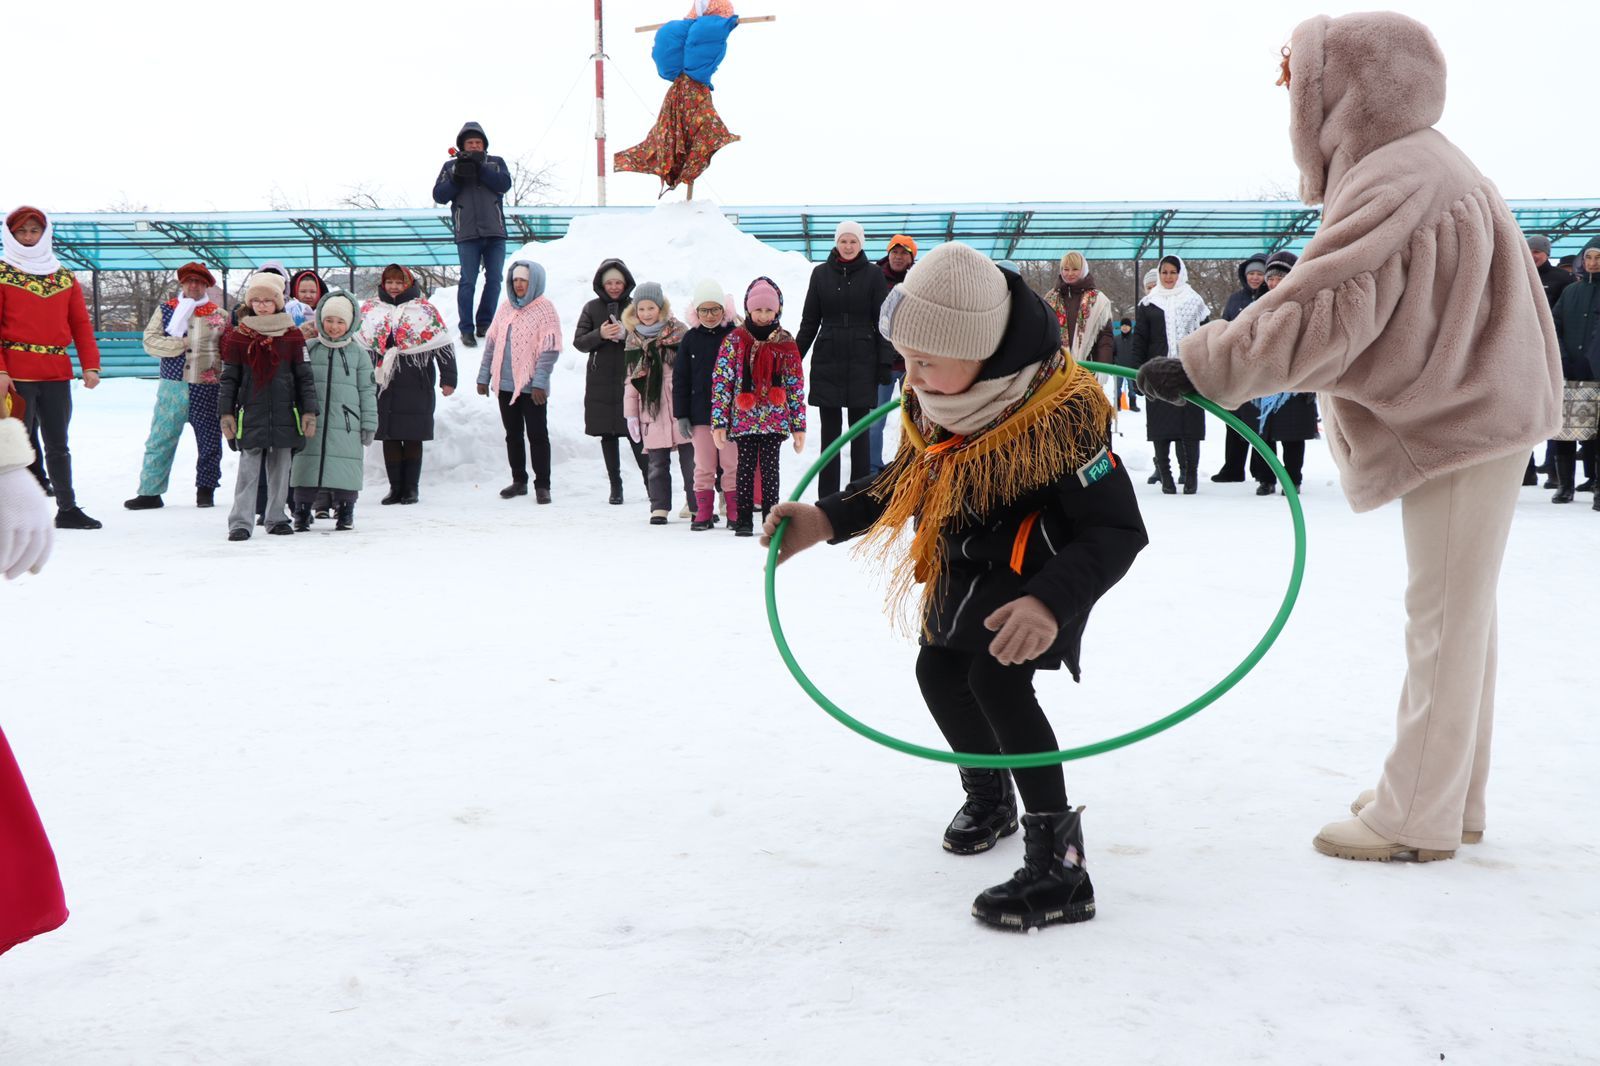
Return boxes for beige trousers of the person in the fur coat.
[1362,451,1528,852]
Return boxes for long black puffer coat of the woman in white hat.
[795,248,894,407]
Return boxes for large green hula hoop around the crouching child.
[766,362,1306,770]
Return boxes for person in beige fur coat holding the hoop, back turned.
[1139,13,1562,861]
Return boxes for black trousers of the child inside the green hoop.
[917,647,1067,813]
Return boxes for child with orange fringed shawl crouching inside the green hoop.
[763,242,1147,930]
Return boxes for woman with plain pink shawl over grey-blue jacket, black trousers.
[478,259,562,503]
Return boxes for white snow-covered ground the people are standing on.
[0,203,1600,1066]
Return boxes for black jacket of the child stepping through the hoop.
[818,274,1149,679]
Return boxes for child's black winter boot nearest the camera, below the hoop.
[973,807,1094,933]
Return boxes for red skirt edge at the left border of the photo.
[0,731,67,954]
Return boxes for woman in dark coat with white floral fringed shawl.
[358,262,456,504]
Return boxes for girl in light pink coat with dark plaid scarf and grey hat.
[622,282,694,525]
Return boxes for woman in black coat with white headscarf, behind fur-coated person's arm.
[1133,256,1211,496]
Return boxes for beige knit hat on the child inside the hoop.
[878,242,1011,362]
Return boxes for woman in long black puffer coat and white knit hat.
[795,221,894,498]
